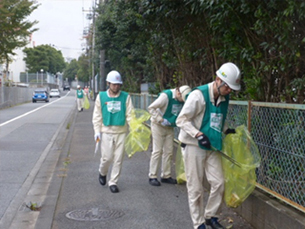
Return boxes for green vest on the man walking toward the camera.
[99,91,128,126]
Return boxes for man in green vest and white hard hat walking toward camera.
[92,71,133,193]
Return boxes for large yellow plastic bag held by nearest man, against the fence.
[222,125,261,208]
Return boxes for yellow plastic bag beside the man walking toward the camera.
[125,109,151,157]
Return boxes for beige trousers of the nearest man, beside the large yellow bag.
[183,145,224,229]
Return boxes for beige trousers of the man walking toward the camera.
[99,133,126,186]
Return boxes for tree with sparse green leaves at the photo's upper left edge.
[0,0,38,72]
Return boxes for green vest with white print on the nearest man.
[196,84,229,150]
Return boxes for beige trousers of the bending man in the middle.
[148,122,174,178]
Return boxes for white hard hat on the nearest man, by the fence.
[216,62,240,91]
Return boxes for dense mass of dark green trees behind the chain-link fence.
[96,0,305,103]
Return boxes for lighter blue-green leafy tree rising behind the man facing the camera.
[96,1,152,92]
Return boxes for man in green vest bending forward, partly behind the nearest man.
[148,85,191,186]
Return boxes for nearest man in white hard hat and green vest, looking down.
[176,62,240,229]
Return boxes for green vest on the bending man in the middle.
[159,90,184,127]
